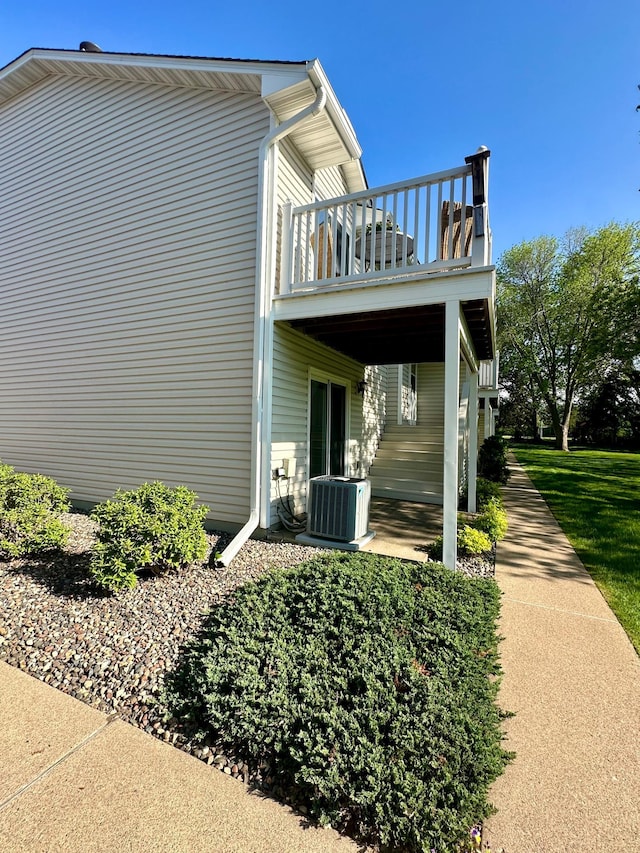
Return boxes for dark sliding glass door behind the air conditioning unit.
[309,379,347,477]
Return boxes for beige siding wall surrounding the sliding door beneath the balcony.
[271,323,386,524]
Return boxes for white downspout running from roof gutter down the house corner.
[217,86,327,566]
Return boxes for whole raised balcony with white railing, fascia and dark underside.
[273,149,495,364]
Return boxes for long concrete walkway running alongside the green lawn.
[484,464,640,853]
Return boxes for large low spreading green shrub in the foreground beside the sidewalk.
[167,554,507,851]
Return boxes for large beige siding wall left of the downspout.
[0,77,269,525]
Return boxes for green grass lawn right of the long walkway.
[513,445,640,654]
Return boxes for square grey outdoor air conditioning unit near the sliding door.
[307,476,371,542]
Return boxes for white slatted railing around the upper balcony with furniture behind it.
[280,152,490,294]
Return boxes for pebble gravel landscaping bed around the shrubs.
[0,513,493,793]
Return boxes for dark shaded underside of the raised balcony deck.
[290,299,493,364]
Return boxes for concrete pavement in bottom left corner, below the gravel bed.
[0,663,359,853]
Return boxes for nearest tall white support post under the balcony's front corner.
[442,299,460,569]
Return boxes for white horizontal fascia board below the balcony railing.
[273,267,494,320]
